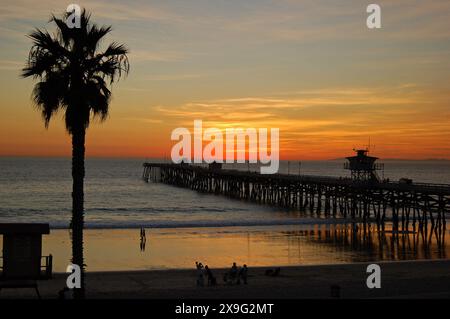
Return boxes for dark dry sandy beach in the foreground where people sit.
[0,260,450,299]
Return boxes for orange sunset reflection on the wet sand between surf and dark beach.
[4,224,450,272]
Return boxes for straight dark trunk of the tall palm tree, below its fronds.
[71,128,86,299]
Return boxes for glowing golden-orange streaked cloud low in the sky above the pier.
[152,83,450,155]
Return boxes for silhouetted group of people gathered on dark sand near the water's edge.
[195,261,248,287]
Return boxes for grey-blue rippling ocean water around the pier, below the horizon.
[0,157,450,228]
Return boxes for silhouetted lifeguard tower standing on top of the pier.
[344,149,384,182]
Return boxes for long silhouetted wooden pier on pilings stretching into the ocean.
[143,163,450,231]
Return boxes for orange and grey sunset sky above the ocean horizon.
[0,0,450,160]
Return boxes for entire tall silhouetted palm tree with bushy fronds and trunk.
[22,10,129,298]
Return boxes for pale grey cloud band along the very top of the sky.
[0,0,450,42]
